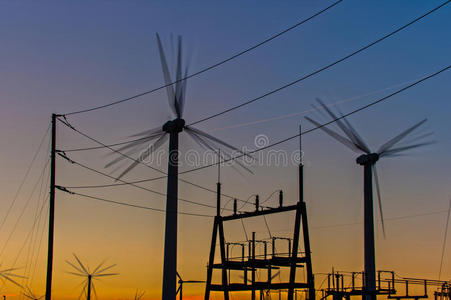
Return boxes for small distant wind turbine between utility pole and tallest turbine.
[66,254,119,300]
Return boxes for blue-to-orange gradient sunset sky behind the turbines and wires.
[0,0,451,299]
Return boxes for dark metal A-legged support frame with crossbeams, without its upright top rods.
[205,197,315,300]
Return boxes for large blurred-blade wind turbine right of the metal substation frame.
[305,99,434,299]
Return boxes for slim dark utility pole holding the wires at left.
[45,114,58,300]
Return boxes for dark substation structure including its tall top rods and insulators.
[205,130,315,300]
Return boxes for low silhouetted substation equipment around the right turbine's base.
[322,271,447,300]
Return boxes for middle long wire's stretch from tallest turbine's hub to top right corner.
[188,0,451,126]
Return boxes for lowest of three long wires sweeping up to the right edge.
[57,63,451,188]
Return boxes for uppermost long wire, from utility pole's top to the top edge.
[61,0,343,116]
